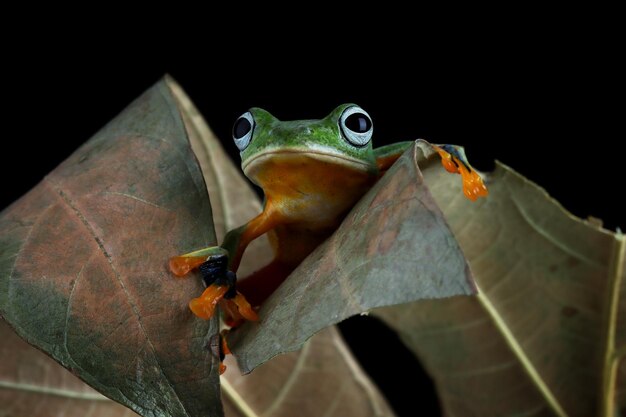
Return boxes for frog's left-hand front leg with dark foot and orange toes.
[170,202,278,324]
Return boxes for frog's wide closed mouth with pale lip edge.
[241,148,372,176]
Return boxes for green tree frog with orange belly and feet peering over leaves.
[169,103,488,326]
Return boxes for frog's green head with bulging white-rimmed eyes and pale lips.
[233,104,377,180]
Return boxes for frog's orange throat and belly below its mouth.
[248,154,376,265]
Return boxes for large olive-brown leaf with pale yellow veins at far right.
[375,158,626,416]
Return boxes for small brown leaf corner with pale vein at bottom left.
[0,320,137,417]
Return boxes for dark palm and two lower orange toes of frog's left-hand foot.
[189,255,259,327]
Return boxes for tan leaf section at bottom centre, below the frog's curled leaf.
[222,327,393,417]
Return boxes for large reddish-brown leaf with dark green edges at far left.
[0,78,221,416]
